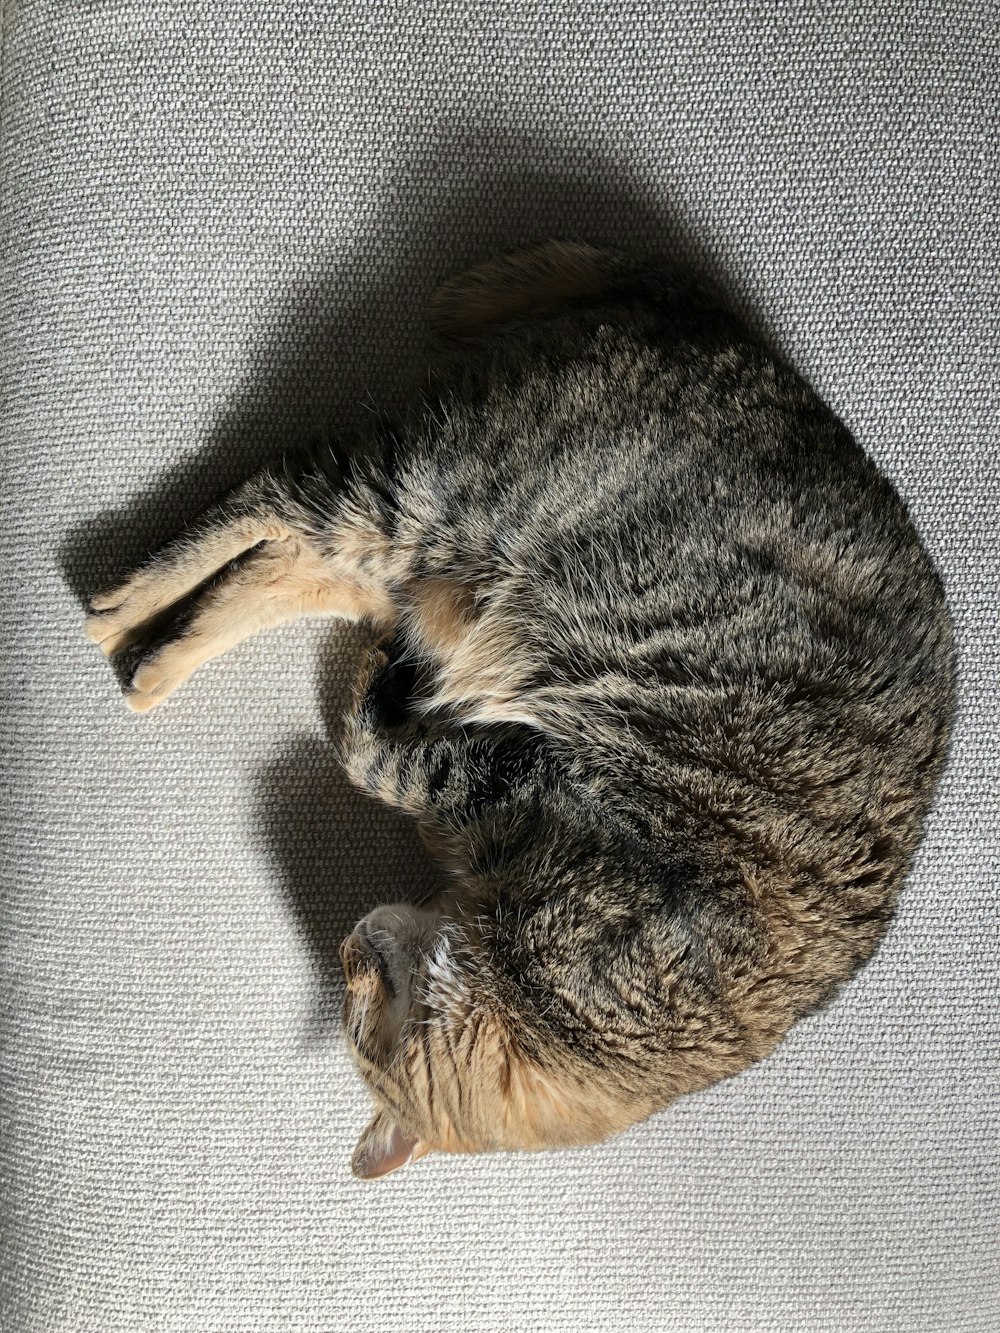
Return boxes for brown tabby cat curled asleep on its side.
[87,241,955,1178]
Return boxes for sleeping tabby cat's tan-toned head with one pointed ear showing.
[341,874,688,1178]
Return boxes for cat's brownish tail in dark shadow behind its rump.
[429,241,635,343]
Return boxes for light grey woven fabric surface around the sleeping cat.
[0,0,1000,1333]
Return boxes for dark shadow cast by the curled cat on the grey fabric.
[60,117,760,1030]
